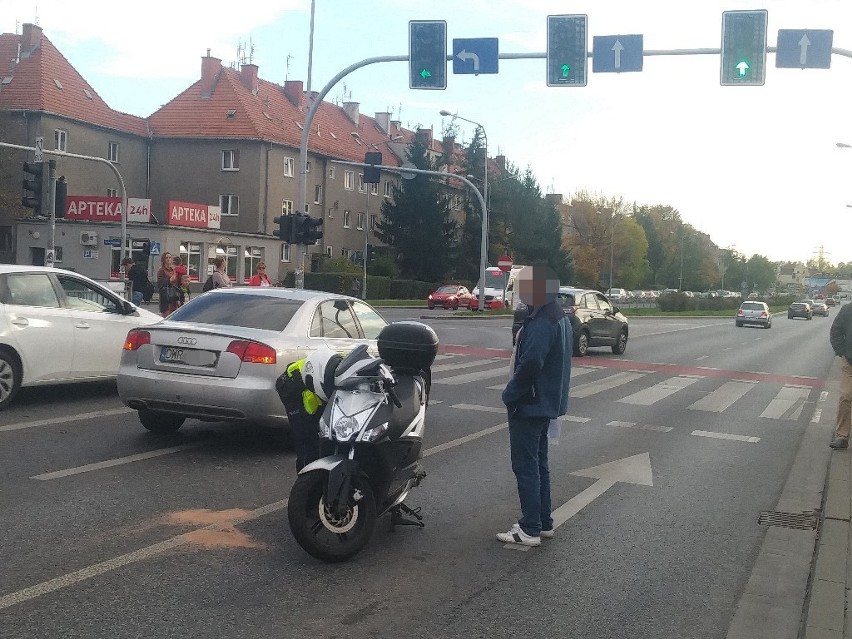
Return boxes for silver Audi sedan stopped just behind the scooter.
[118,287,387,433]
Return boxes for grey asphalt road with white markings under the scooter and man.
[0,309,836,638]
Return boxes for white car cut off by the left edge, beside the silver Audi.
[0,264,162,410]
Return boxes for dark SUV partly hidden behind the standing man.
[512,286,629,357]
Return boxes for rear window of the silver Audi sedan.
[169,294,304,331]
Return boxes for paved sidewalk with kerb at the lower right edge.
[727,358,852,639]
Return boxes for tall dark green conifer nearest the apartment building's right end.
[376,130,456,282]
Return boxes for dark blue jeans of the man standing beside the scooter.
[509,417,553,537]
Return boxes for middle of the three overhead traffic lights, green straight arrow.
[547,15,589,87]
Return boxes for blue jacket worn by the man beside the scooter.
[503,302,574,419]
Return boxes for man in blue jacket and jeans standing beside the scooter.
[497,266,573,546]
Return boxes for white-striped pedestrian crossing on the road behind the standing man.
[432,354,824,426]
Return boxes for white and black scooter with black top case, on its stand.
[287,322,438,562]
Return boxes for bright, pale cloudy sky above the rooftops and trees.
[0,0,852,264]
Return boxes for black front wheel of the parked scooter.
[287,470,376,563]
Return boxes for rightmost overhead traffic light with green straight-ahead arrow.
[719,9,769,86]
